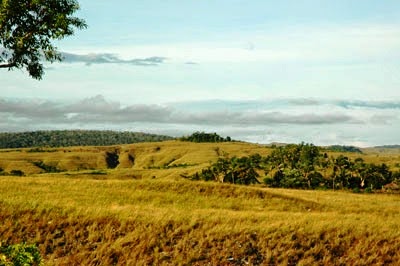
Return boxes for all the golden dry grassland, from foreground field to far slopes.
[0,142,400,265]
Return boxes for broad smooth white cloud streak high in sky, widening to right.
[65,24,400,64]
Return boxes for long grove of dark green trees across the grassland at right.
[190,143,400,192]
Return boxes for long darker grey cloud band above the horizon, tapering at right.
[0,95,372,125]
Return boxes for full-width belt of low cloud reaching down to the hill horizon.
[0,95,400,146]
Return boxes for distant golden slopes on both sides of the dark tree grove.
[0,141,400,177]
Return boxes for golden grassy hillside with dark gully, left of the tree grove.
[0,141,270,177]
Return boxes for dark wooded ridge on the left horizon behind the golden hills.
[0,130,172,149]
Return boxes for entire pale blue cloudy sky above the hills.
[0,0,400,147]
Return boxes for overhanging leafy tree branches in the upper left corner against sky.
[0,0,87,80]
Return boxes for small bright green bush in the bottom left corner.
[0,243,42,266]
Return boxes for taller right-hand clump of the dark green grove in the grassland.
[264,143,393,191]
